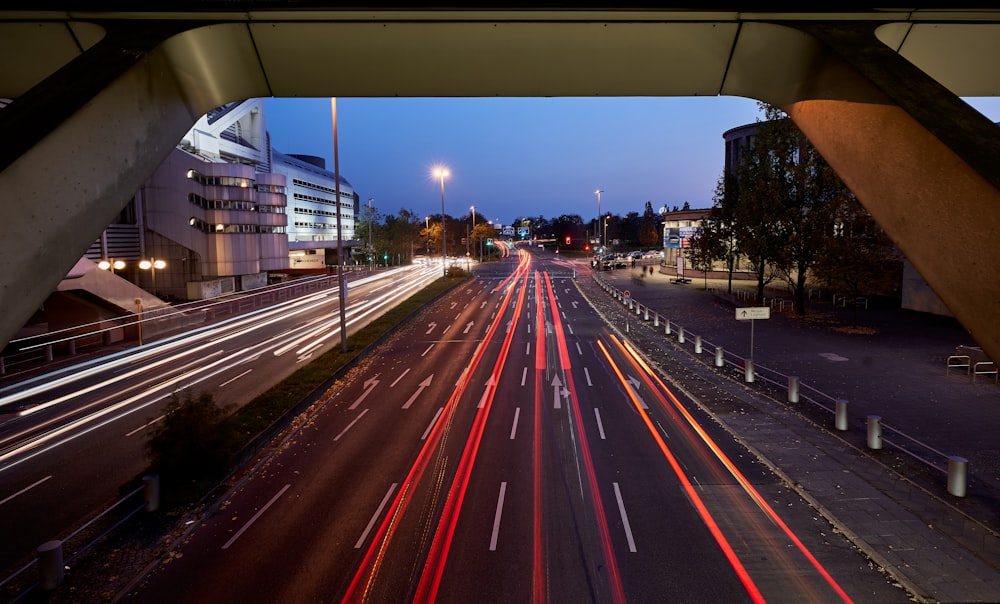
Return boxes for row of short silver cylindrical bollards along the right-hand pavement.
[601,283,969,497]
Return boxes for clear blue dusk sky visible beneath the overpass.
[265,97,1000,229]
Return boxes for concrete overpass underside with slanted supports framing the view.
[0,8,1000,359]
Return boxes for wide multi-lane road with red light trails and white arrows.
[115,247,909,603]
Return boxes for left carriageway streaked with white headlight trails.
[0,265,441,568]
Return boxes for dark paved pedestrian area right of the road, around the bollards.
[577,263,1000,602]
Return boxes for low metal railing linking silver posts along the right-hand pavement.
[593,274,976,497]
